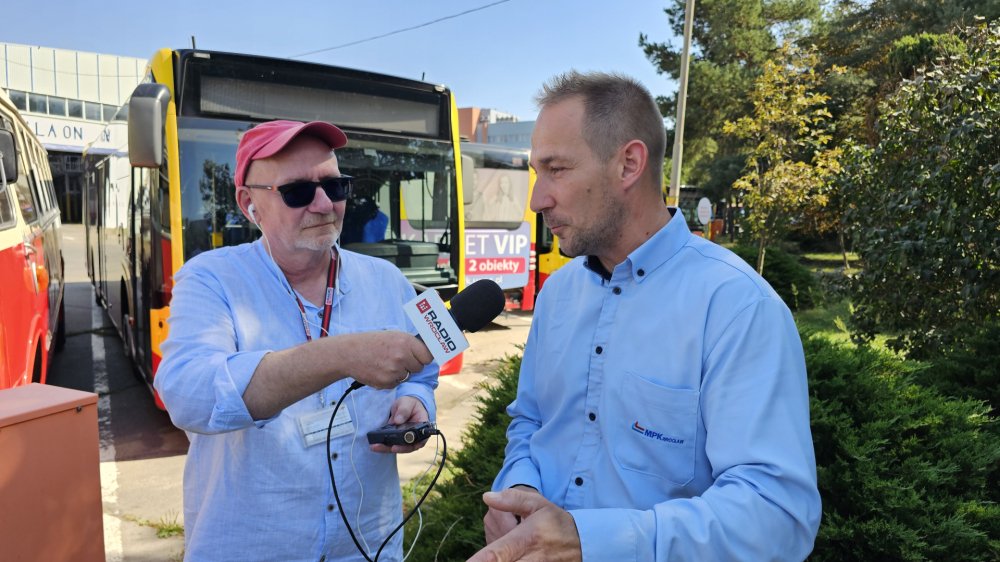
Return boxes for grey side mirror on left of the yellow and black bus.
[128,84,170,168]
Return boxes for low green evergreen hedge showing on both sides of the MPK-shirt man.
[405,336,1000,562]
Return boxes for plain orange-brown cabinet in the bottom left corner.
[0,384,104,562]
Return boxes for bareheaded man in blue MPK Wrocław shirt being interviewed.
[472,72,821,562]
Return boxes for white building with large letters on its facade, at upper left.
[0,43,146,223]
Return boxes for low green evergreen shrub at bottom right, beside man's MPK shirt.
[803,336,1000,561]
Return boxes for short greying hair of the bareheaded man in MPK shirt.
[535,70,667,191]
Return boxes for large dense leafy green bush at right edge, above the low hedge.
[840,24,1000,356]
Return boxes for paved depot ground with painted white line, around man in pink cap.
[47,225,531,562]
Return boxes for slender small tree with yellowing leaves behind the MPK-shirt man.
[724,43,840,273]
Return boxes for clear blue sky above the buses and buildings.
[0,0,680,119]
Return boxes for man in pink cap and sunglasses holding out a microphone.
[154,121,438,562]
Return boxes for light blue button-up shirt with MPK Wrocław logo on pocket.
[493,209,821,562]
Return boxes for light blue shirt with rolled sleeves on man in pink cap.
[154,240,438,562]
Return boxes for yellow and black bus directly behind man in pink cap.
[84,49,465,400]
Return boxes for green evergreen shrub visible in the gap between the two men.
[403,355,521,562]
